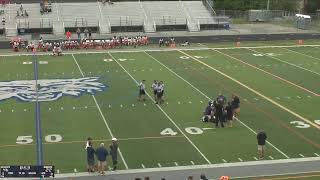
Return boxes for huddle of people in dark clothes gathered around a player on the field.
[201,94,240,127]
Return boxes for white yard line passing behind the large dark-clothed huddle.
[145,52,290,158]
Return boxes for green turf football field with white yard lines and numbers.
[0,45,320,176]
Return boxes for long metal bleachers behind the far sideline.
[0,1,228,36]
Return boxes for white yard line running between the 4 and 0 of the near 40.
[108,52,211,164]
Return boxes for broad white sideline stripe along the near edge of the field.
[55,157,320,178]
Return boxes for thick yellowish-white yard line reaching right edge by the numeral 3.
[179,51,320,130]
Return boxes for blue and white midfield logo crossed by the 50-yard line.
[0,77,107,102]
